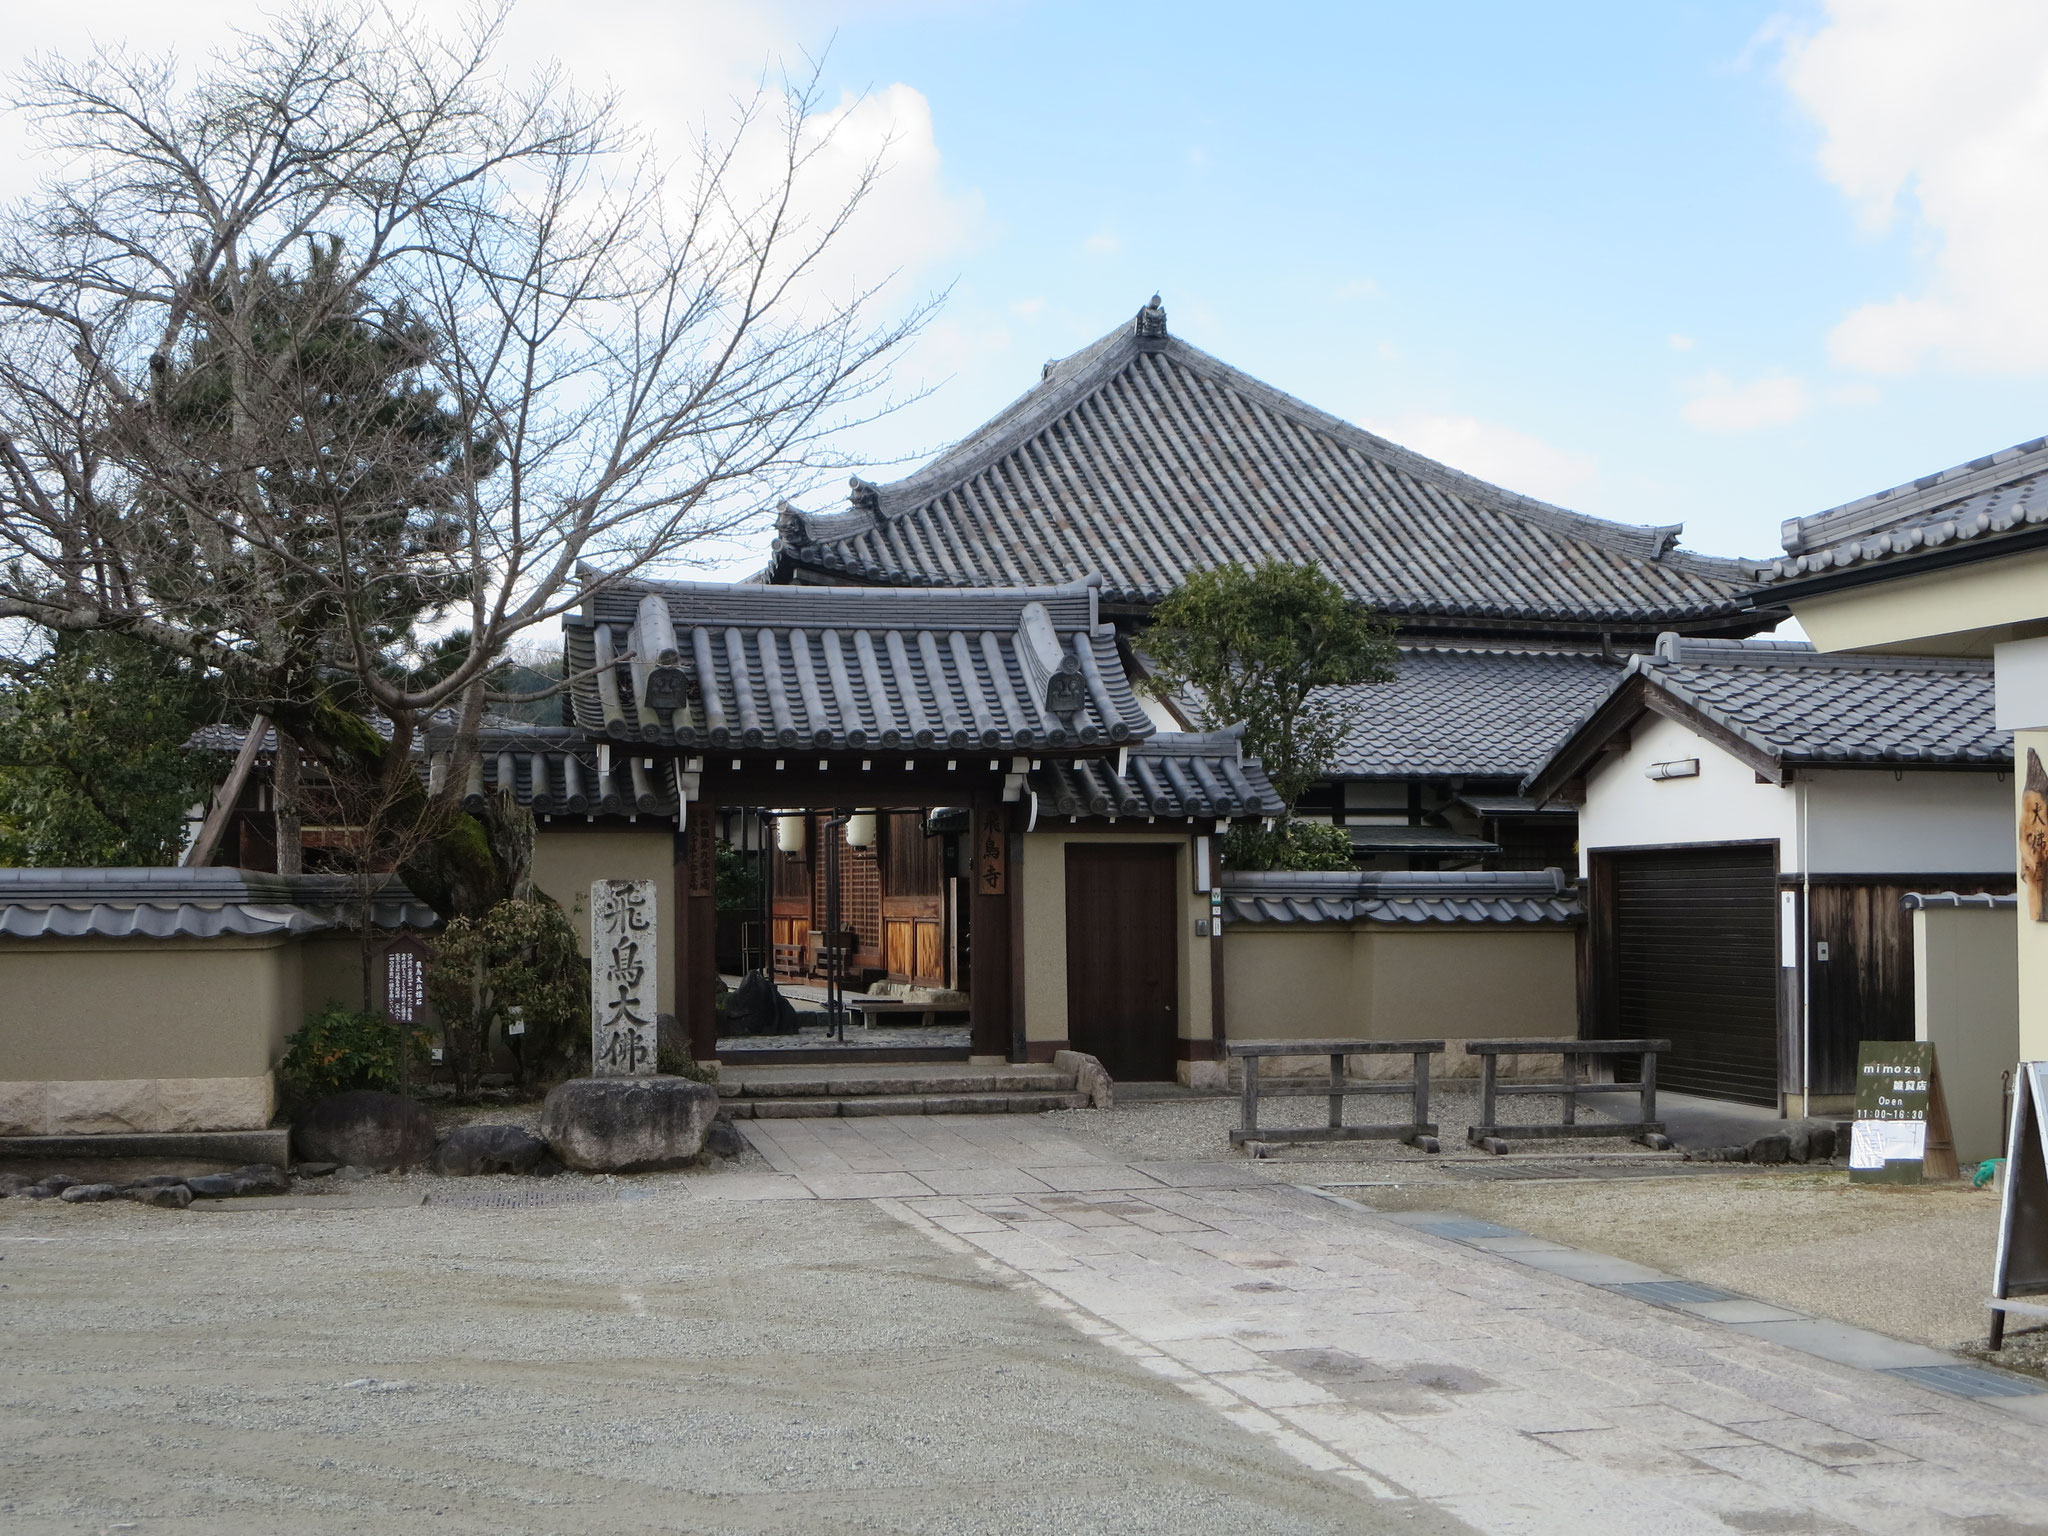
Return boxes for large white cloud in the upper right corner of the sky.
[1782,0,2048,373]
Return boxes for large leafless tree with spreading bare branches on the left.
[0,6,930,909]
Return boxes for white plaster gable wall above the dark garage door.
[1579,715,1794,874]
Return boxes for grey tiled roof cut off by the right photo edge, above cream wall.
[1765,438,2048,582]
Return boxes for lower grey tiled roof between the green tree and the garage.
[1331,645,1622,778]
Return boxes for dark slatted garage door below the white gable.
[1604,848,1778,1104]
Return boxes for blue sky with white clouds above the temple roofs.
[16,0,2048,569]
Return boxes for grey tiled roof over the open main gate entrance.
[563,580,1153,752]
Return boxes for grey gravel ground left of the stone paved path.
[0,1174,1462,1536]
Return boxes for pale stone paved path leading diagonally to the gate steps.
[733,1116,2048,1536]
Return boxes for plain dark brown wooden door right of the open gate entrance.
[1067,844,1180,1083]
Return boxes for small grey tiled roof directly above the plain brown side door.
[1030,725,1286,821]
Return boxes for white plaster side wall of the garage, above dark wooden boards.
[1784,768,2013,874]
